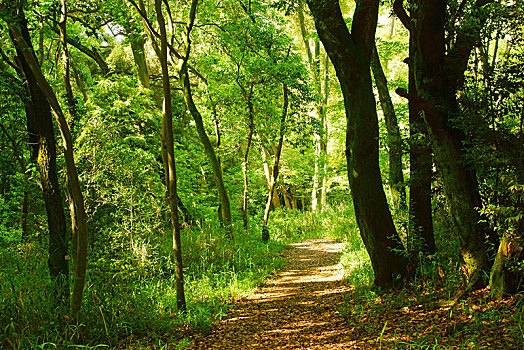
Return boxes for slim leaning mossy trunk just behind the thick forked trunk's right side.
[371,46,406,211]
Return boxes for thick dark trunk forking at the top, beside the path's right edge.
[308,0,407,288]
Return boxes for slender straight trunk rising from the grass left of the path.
[155,0,186,311]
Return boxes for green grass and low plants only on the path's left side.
[0,224,284,349]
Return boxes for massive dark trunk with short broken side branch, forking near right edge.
[395,0,489,290]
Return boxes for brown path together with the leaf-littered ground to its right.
[186,239,524,349]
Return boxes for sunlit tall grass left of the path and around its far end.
[0,206,372,349]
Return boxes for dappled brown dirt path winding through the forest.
[189,239,355,349]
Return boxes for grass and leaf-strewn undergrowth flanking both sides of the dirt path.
[0,206,524,349]
